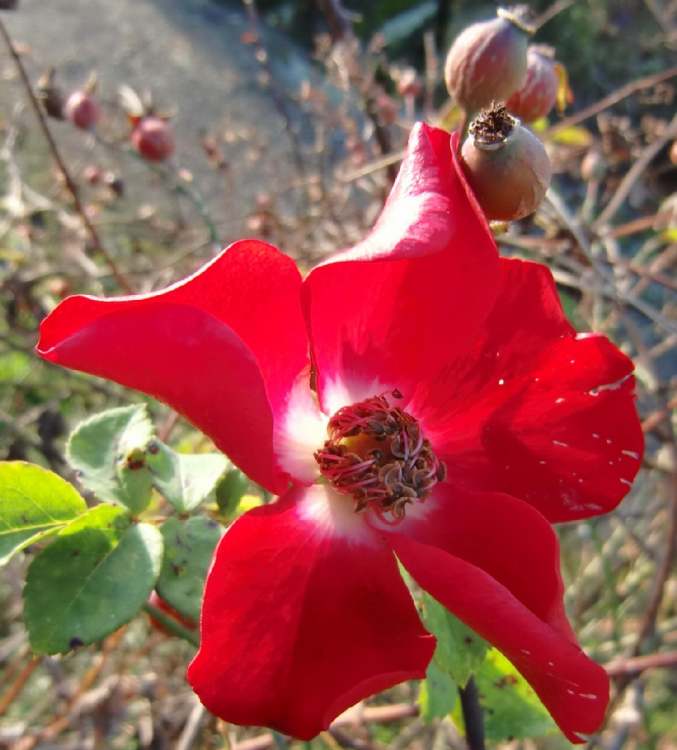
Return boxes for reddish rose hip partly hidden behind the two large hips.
[505,44,559,122]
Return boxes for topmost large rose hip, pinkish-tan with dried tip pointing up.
[444,5,533,114]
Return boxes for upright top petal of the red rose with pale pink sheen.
[304,124,497,414]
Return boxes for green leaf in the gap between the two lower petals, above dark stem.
[423,593,489,686]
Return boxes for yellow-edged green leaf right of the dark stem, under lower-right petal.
[454,648,557,741]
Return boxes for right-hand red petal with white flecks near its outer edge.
[410,259,643,522]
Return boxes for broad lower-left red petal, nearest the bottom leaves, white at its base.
[188,485,435,739]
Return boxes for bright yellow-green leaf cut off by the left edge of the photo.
[0,461,87,565]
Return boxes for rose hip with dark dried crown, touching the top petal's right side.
[461,104,552,221]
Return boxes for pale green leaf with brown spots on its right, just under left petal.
[66,405,153,513]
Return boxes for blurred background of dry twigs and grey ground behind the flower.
[0,0,677,750]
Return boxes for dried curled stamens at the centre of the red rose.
[314,391,446,520]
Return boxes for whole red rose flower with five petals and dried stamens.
[38,125,642,741]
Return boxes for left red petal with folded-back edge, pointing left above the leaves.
[37,240,307,491]
